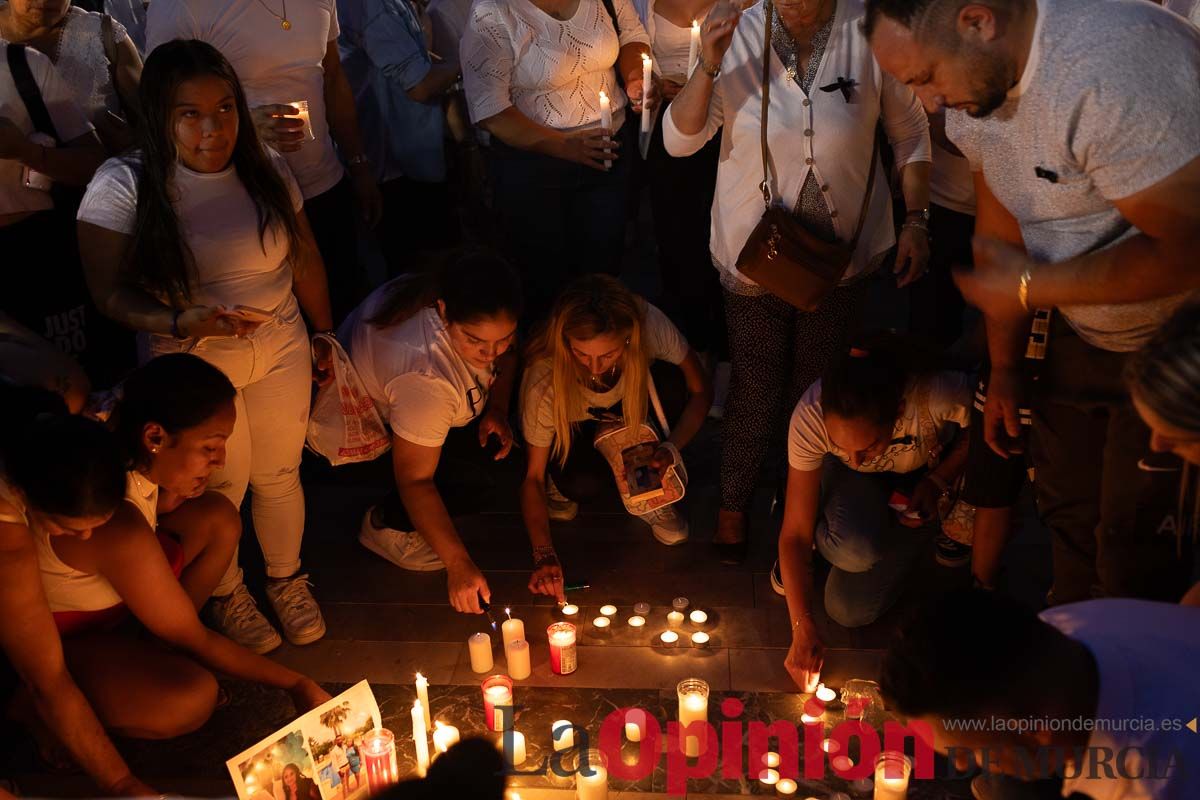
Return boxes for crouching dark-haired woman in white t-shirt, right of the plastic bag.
[340,252,522,614]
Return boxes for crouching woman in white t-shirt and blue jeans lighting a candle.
[772,336,972,691]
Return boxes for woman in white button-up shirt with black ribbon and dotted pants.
[662,0,930,563]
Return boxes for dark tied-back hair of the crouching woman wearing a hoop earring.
[116,353,238,467]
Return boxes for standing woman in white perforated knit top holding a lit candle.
[460,0,656,318]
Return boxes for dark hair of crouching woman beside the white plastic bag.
[367,248,524,327]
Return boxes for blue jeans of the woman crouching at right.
[815,456,936,627]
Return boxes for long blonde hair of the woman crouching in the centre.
[529,275,650,465]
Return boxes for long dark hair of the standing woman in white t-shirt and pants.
[125,40,300,307]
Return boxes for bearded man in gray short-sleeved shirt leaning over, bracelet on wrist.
[866,0,1200,602]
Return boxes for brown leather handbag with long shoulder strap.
[737,0,876,311]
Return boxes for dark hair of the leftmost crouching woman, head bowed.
[0,384,125,517]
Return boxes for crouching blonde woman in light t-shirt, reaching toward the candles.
[521,275,713,599]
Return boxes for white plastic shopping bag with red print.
[306,333,391,467]
